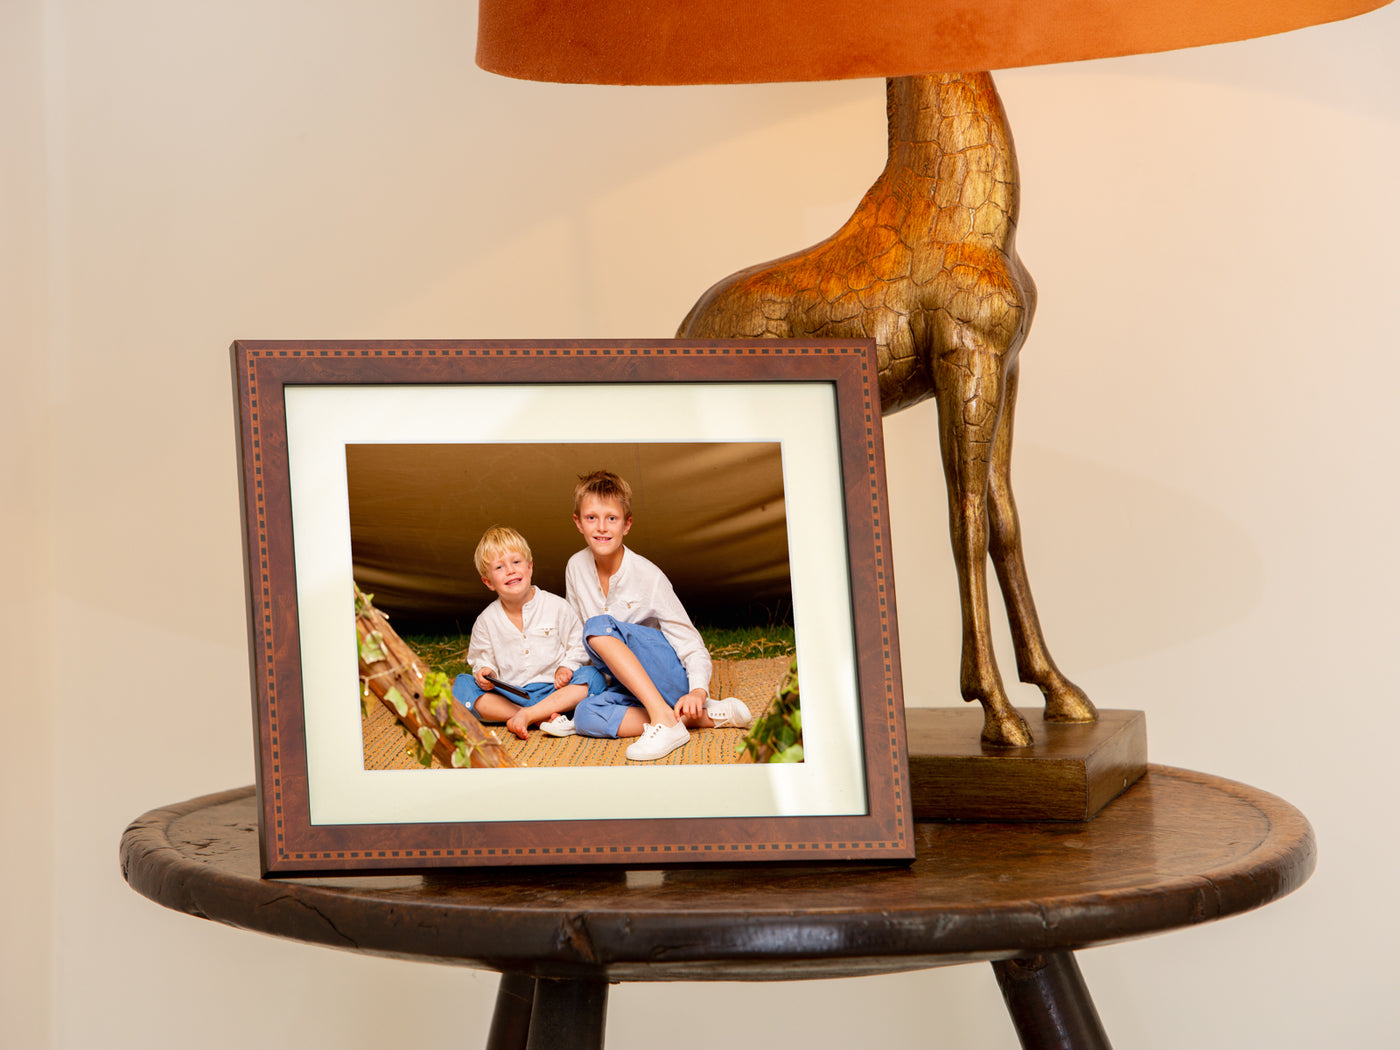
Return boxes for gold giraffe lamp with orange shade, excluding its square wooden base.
[476,0,1389,749]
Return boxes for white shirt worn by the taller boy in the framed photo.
[564,546,713,692]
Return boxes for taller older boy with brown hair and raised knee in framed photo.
[546,470,752,762]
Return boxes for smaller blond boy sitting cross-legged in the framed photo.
[452,525,605,739]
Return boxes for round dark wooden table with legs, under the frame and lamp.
[122,766,1316,1050]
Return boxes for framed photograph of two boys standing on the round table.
[232,340,914,875]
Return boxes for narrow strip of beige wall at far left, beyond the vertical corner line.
[0,0,55,1047]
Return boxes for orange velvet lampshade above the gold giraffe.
[476,0,1389,84]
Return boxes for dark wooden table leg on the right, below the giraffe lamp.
[991,952,1113,1050]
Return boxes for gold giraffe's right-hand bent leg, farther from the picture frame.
[987,361,1099,722]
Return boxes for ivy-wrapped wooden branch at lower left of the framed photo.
[354,584,519,769]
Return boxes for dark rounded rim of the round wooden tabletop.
[120,764,1316,980]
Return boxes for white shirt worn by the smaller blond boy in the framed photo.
[466,587,588,686]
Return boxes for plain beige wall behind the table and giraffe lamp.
[10,0,1400,1050]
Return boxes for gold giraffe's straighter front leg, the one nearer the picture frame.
[934,347,1030,748]
